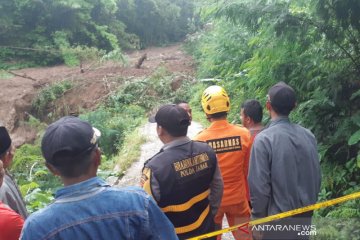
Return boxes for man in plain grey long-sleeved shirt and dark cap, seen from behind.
[248,82,321,239]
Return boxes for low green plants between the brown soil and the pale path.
[80,68,194,157]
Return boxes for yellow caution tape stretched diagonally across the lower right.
[188,192,360,240]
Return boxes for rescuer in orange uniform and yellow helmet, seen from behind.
[195,86,250,240]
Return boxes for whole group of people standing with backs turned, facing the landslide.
[0,82,321,240]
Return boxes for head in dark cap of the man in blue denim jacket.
[41,117,101,178]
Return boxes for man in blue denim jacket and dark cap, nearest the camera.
[21,117,177,240]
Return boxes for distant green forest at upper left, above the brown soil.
[0,0,197,68]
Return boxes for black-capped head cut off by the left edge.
[0,126,15,169]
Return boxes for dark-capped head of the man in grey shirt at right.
[266,82,296,116]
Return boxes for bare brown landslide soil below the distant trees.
[0,45,194,146]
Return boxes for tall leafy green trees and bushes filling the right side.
[187,0,360,239]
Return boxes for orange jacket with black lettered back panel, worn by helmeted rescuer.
[194,120,251,208]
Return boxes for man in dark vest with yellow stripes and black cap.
[141,104,223,239]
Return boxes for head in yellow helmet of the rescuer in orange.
[201,85,230,119]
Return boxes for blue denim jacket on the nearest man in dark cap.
[21,177,178,240]
